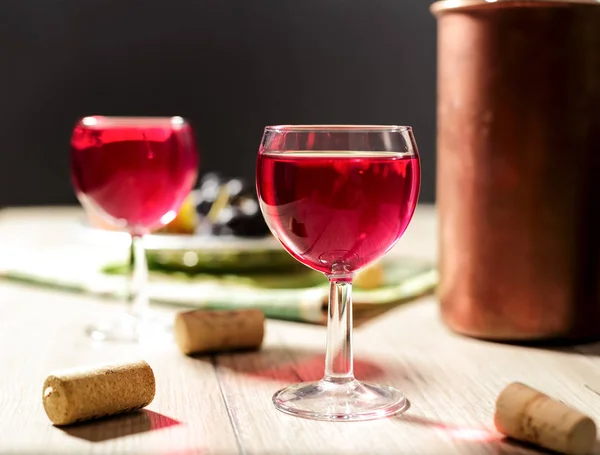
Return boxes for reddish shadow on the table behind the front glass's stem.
[195,347,384,382]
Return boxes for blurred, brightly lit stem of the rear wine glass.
[128,235,149,318]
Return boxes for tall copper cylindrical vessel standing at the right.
[431,0,600,342]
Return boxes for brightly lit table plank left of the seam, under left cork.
[0,282,239,454]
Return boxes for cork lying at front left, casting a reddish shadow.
[42,361,156,425]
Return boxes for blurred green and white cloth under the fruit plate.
[1,240,438,324]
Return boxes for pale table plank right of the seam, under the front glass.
[217,299,600,454]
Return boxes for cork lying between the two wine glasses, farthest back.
[175,309,265,354]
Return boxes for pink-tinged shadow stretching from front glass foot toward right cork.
[394,412,560,455]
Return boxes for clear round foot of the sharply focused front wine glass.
[273,379,410,422]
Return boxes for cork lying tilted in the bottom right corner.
[494,382,596,455]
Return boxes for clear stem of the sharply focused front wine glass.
[323,277,354,383]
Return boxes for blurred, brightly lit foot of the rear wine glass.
[86,313,173,343]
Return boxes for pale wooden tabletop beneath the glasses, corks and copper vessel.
[0,206,600,455]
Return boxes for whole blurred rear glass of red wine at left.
[71,116,198,341]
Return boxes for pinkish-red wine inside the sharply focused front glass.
[257,151,420,274]
